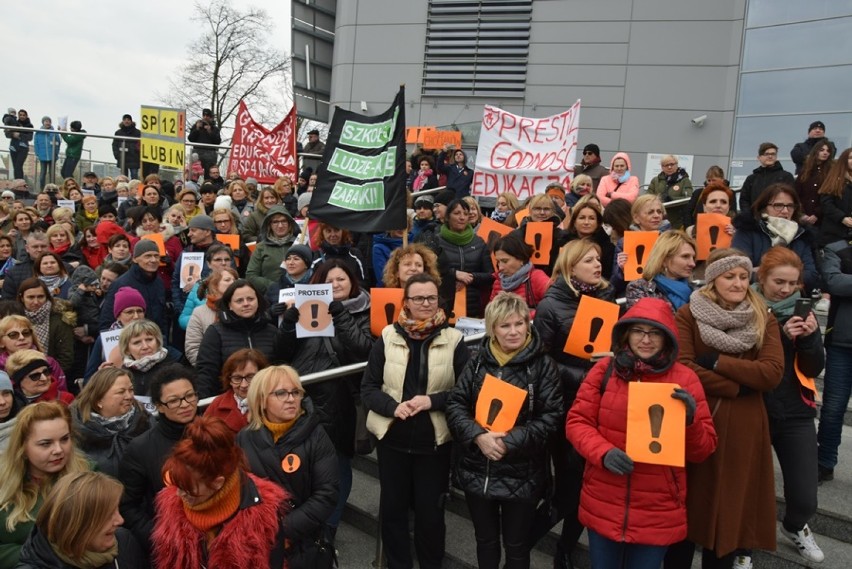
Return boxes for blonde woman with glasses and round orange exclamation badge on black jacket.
[237,366,339,569]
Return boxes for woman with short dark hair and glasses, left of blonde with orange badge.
[118,363,198,551]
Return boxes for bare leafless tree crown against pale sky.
[159,0,292,142]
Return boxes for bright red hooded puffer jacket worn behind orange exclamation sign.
[565,298,717,546]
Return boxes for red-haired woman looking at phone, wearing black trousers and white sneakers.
[752,247,825,563]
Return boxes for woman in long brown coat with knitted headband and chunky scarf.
[668,249,784,568]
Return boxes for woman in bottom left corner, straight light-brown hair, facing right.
[18,472,145,569]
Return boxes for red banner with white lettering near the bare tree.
[228,101,299,184]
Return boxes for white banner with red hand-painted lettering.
[471,99,580,201]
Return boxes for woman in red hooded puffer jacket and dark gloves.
[565,298,716,569]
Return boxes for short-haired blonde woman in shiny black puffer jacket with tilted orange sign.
[447,292,562,569]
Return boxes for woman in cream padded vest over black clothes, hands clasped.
[361,273,469,569]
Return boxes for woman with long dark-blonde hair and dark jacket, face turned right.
[71,367,153,476]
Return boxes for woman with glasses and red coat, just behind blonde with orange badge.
[204,348,269,433]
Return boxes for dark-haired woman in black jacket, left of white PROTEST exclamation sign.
[195,279,282,399]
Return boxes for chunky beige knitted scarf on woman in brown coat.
[689,291,758,354]
